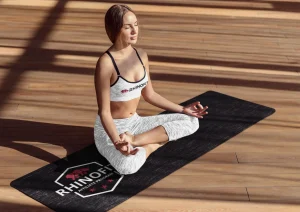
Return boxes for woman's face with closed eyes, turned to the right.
[119,11,139,44]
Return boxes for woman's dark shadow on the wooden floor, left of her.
[0,119,95,171]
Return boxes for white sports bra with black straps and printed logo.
[106,47,148,101]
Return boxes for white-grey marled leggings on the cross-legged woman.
[94,113,199,174]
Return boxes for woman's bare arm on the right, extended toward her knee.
[140,50,183,113]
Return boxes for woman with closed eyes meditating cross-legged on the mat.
[94,5,208,174]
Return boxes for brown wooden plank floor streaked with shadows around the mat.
[0,0,300,212]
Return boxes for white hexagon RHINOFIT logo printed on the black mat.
[55,162,123,198]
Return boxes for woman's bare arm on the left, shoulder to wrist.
[94,54,120,143]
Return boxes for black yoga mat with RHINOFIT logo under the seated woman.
[11,91,275,212]
